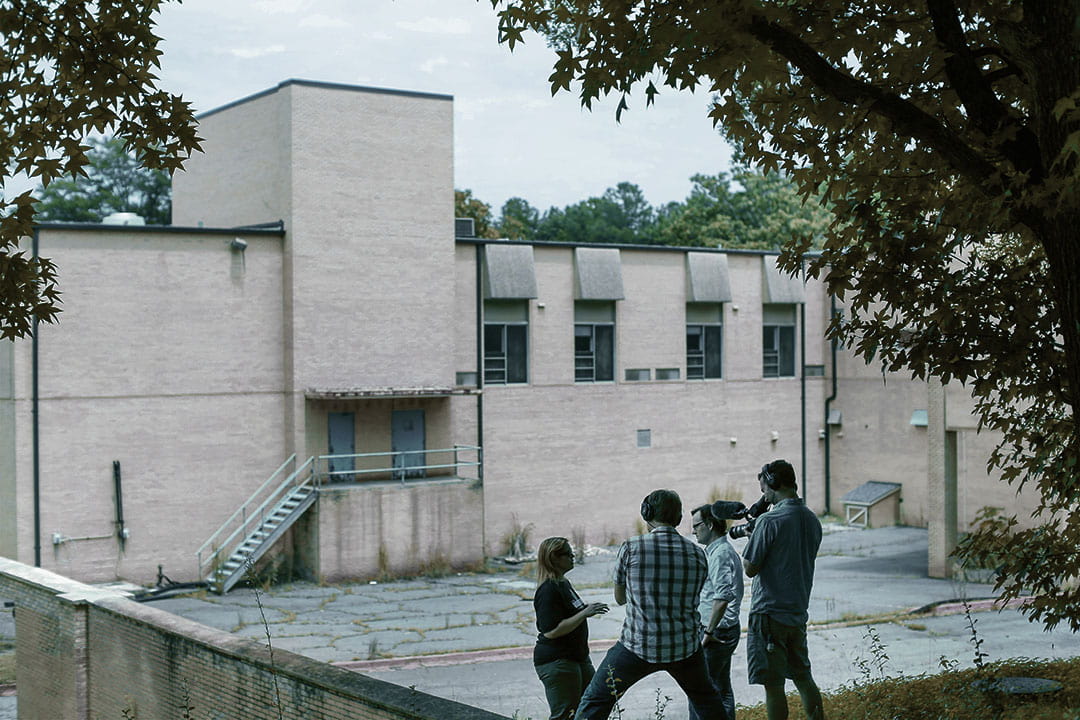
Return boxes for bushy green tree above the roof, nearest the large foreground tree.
[654,167,832,249]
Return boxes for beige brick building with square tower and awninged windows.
[0,81,1036,583]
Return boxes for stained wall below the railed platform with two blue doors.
[316,479,484,582]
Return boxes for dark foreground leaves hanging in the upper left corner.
[0,0,199,338]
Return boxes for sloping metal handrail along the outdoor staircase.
[195,453,315,578]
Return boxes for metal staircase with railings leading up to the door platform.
[198,454,319,595]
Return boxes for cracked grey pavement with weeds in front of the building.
[0,525,1080,720]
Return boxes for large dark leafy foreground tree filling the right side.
[492,0,1080,630]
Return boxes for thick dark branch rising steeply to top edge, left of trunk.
[927,0,1045,182]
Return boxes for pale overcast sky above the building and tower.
[158,0,730,214]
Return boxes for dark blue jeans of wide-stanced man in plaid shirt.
[575,642,728,720]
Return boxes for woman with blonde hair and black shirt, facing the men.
[532,538,608,720]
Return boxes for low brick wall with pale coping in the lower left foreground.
[0,558,502,720]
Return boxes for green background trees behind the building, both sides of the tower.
[37,137,833,249]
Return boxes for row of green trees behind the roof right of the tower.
[455,166,833,249]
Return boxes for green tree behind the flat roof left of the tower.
[37,138,173,225]
